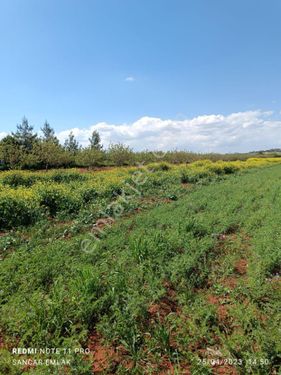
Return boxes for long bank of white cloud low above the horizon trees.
[57,110,281,152]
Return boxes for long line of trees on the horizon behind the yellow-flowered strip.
[0,117,258,170]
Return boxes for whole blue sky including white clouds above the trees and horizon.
[0,0,281,152]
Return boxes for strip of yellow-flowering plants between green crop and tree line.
[0,158,281,229]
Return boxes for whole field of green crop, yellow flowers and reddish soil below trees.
[0,162,281,375]
